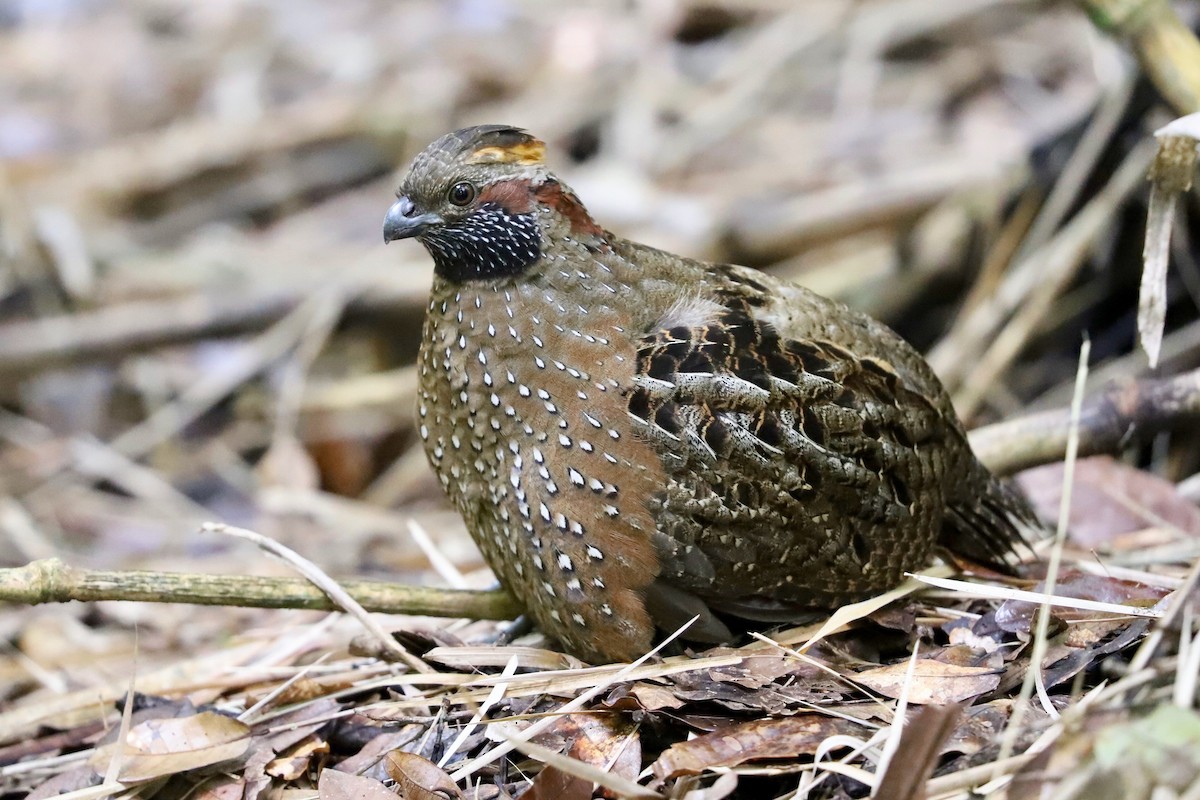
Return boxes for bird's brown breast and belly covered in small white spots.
[418,262,664,661]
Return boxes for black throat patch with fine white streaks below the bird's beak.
[420,203,541,283]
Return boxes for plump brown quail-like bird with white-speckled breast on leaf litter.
[383,125,1030,663]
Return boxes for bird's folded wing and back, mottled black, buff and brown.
[628,260,1019,618]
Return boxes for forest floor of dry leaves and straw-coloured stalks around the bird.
[0,0,1200,800]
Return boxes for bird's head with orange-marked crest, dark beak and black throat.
[383,125,604,282]
